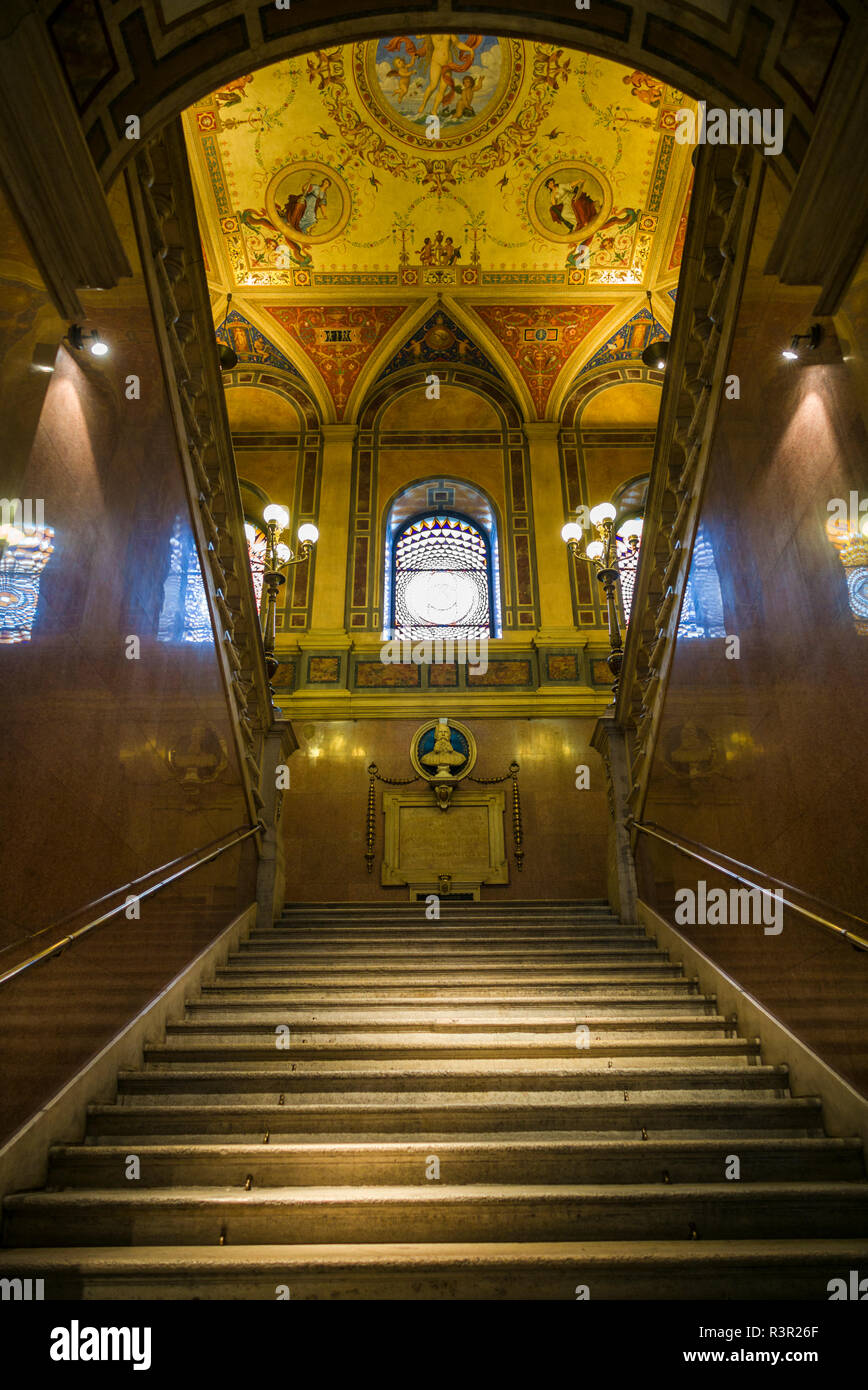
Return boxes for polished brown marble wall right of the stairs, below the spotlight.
[641,170,868,1091]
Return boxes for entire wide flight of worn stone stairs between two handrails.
[1,902,868,1300]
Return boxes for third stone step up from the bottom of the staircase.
[47,1133,865,1190]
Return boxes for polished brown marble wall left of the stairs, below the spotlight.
[0,186,255,1138]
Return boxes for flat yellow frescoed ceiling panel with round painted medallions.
[186,35,689,288]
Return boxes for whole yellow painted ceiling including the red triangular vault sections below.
[184,35,691,420]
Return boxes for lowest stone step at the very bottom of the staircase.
[3,1238,868,1302]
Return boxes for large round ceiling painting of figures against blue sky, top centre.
[352,33,524,153]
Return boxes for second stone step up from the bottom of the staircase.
[4,1182,868,1245]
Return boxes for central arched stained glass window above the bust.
[394,514,491,641]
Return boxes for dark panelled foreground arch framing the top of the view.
[49,0,834,186]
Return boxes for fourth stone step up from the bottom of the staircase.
[81,1091,823,1143]
